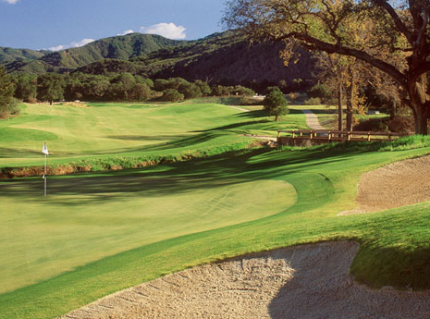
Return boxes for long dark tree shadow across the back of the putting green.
[0,149,356,205]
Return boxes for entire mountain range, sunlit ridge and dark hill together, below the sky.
[0,31,315,89]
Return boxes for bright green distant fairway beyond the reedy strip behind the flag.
[0,99,306,168]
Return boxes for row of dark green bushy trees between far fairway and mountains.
[8,73,255,104]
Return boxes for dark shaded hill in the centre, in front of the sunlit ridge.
[78,31,315,89]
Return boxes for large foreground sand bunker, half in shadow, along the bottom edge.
[58,242,430,319]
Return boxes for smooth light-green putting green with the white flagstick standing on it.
[0,174,297,293]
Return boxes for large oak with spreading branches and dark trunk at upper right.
[224,0,430,134]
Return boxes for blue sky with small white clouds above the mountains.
[0,0,225,50]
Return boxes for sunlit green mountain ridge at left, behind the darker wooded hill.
[6,33,183,73]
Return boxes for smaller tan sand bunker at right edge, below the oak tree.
[339,156,430,215]
